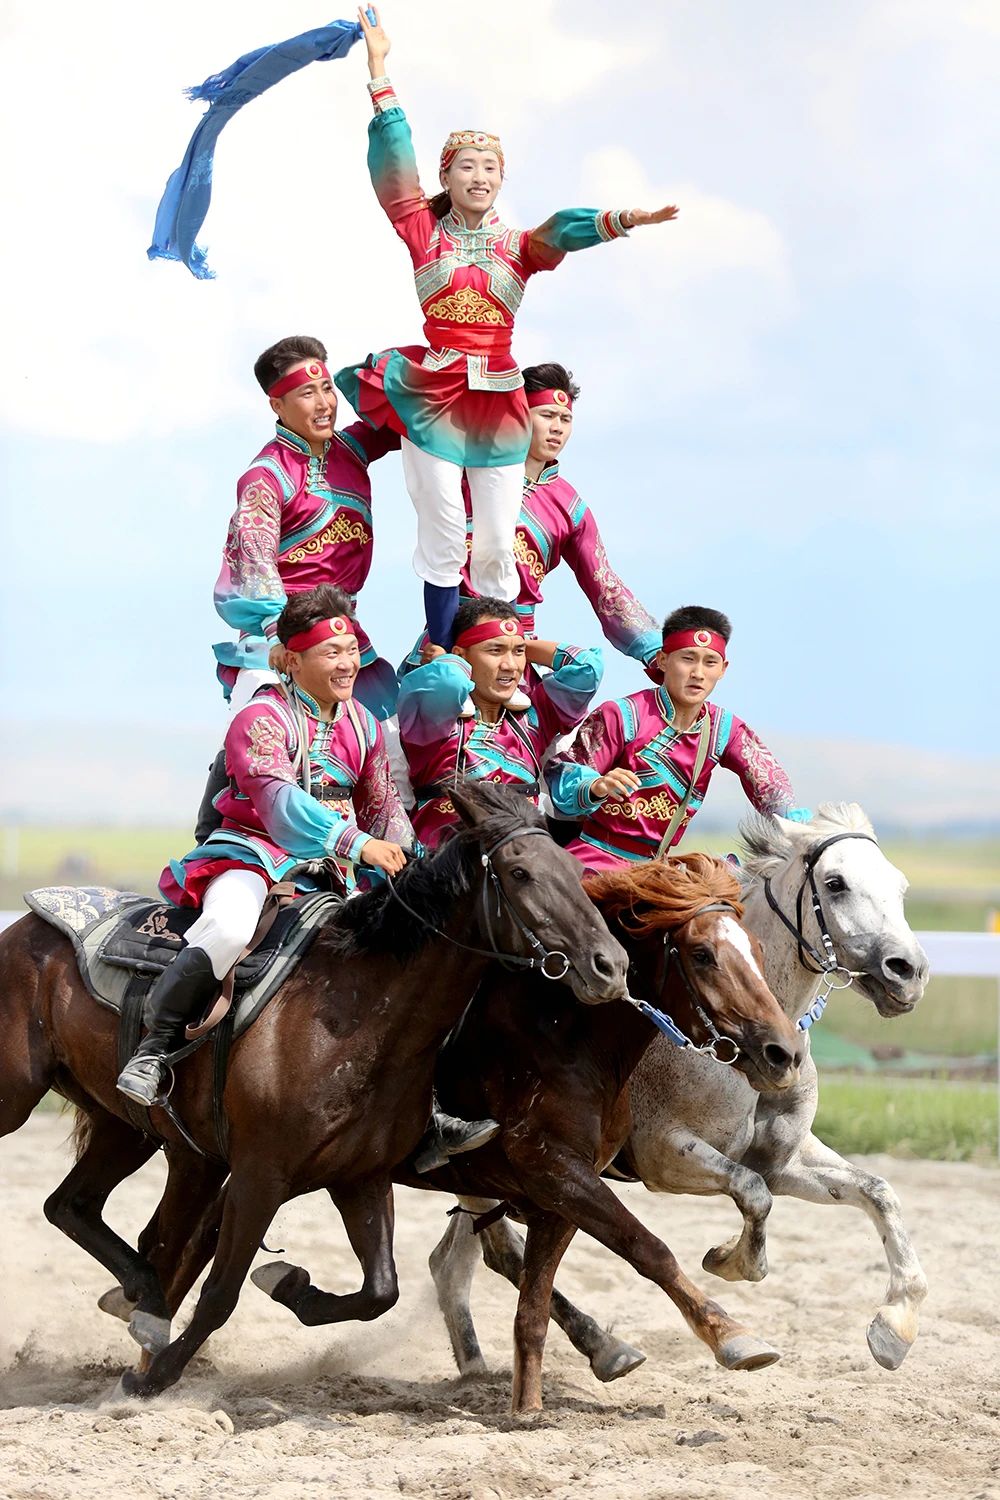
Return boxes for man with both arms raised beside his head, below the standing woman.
[399,599,603,849]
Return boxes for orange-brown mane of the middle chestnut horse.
[586,854,744,938]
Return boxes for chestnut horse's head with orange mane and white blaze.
[588,854,805,1091]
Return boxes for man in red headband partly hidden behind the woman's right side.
[405,363,660,675]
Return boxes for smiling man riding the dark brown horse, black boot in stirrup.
[118,584,412,1106]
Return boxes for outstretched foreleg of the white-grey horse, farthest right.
[768,1134,927,1370]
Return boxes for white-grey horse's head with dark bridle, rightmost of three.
[741,803,928,1017]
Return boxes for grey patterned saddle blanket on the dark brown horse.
[24,885,343,1038]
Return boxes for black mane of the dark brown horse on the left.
[316,779,544,960]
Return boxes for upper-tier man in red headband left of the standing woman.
[213,336,399,719]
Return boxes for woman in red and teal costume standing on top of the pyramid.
[336,8,678,650]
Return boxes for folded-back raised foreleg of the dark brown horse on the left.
[250,1181,399,1328]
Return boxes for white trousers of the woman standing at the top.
[402,438,525,600]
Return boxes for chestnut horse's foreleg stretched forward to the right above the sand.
[512,1151,780,1370]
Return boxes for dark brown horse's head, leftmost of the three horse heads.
[450,780,628,1005]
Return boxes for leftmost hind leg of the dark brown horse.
[43,1106,169,1349]
